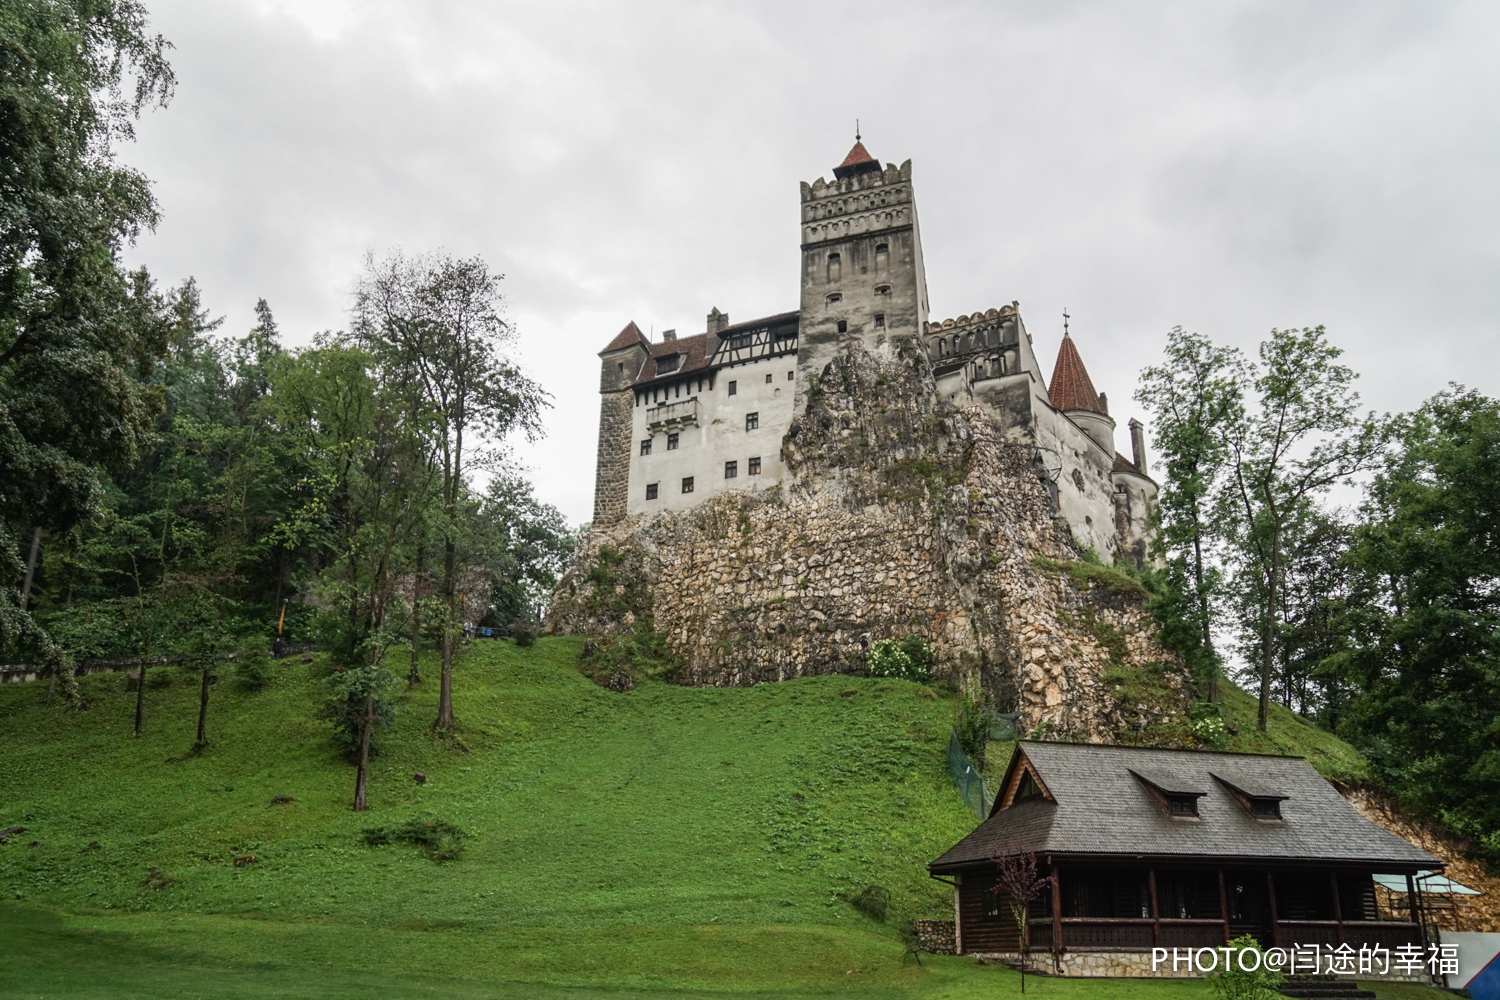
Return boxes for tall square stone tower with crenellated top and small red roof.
[795,136,927,412]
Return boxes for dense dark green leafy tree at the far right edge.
[1344,385,1500,862]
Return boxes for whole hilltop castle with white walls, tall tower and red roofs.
[594,141,1157,565]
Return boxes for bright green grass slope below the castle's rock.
[0,639,1404,999]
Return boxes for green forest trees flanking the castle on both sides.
[0,0,1500,861]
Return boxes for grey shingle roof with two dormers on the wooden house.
[929,741,1443,874]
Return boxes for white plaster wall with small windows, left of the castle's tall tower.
[627,354,797,514]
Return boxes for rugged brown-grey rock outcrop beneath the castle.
[549,342,1187,739]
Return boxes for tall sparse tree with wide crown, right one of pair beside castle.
[1221,327,1382,732]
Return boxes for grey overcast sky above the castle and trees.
[122,0,1500,523]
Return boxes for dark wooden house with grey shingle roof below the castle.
[929,741,1443,975]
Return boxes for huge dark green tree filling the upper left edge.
[0,0,174,671]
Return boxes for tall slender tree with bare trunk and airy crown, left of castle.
[354,252,546,729]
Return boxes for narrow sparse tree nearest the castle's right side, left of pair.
[1136,327,1247,702]
